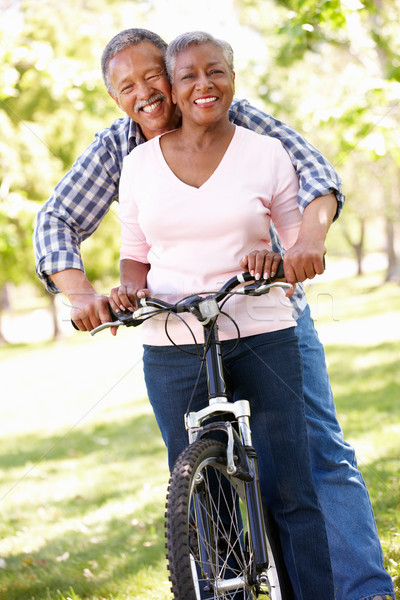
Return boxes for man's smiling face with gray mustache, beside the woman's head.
[108,41,178,140]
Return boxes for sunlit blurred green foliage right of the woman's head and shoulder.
[237,0,400,278]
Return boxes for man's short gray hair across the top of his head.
[101,29,167,96]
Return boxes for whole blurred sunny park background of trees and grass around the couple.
[0,0,400,600]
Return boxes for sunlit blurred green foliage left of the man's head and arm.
[0,0,131,288]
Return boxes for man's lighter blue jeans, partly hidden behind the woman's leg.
[296,306,394,600]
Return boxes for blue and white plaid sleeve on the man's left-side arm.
[33,119,129,293]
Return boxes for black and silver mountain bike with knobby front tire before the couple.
[86,263,293,600]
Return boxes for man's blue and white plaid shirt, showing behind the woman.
[33,100,344,317]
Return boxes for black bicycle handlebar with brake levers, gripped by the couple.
[71,261,292,335]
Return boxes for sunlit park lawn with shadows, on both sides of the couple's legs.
[0,274,400,600]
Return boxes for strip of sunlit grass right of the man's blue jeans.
[307,273,400,599]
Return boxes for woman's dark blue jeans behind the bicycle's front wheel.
[143,328,334,600]
